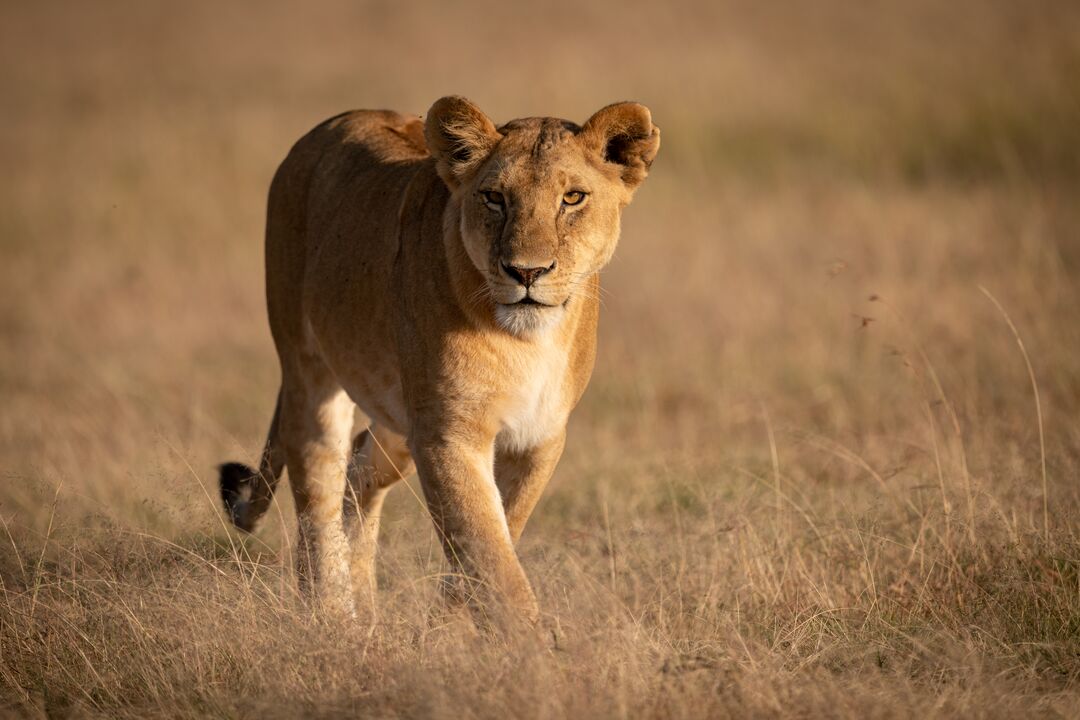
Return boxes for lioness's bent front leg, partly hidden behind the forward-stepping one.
[495,430,566,543]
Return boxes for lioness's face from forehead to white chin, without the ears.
[461,119,626,332]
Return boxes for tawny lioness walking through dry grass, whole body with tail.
[220,97,660,621]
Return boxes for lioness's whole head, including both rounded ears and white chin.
[427,98,659,336]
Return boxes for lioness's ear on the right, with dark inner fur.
[581,103,660,189]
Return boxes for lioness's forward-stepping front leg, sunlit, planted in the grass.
[410,427,539,622]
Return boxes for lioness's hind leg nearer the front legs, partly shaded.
[343,425,415,609]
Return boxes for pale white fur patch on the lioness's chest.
[496,353,569,451]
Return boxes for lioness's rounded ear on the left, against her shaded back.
[423,95,502,190]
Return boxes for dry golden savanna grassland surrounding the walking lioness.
[0,0,1080,718]
